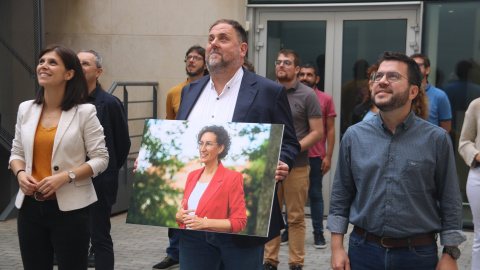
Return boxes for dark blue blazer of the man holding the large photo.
[177,68,300,247]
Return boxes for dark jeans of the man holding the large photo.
[180,230,264,270]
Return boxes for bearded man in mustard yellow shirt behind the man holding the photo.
[152,45,208,270]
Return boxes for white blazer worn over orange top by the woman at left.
[8,100,108,211]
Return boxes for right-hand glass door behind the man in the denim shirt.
[334,11,419,139]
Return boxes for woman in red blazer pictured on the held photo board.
[176,126,247,233]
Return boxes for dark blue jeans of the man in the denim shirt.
[348,232,438,270]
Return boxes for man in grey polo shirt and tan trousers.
[263,49,323,270]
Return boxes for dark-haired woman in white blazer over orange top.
[9,45,108,270]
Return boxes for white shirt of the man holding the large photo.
[187,67,243,122]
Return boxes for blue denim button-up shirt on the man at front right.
[327,112,466,246]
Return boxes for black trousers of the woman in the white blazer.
[17,196,90,270]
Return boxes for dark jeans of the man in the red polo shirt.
[308,158,323,232]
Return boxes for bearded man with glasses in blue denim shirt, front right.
[327,52,466,270]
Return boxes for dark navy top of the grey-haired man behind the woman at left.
[93,86,130,206]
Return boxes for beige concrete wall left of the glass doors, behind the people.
[44,0,246,150]
